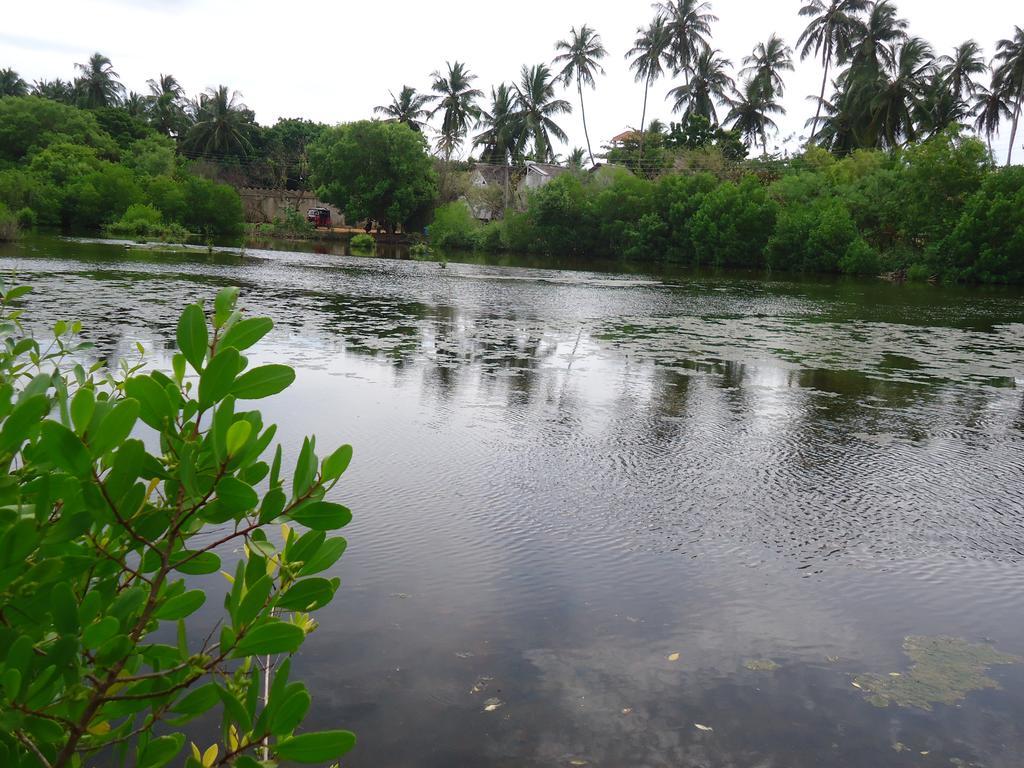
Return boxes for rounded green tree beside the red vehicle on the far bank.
[309,121,437,231]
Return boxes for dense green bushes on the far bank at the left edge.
[0,96,243,234]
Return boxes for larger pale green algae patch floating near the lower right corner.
[853,636,1021,711]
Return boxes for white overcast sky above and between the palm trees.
[0,0,1024,161]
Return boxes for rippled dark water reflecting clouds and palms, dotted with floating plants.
[0,237,1024,768]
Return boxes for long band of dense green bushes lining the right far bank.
[430,129,1024,282]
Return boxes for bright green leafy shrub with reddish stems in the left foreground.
[0,285,355,768]
